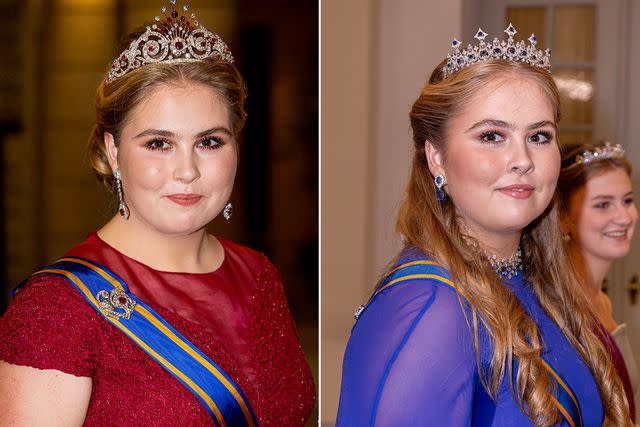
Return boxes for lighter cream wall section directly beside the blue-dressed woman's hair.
[371,0,463,275]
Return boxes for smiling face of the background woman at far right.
[565,167,638,265]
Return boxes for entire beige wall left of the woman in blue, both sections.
[320,0,464,425]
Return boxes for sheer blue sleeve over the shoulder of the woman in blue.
[337,280,491,426]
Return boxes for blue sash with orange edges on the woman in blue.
[356,259,583,427]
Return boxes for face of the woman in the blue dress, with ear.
[425,73,560,249]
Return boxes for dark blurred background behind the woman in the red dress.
[0,0,318,425]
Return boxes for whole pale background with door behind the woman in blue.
[321,0,640,425]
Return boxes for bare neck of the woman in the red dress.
[98,215,224,273]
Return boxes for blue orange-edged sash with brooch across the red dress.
[12,257,258,427]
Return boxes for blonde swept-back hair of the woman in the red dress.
[89,31,247,190]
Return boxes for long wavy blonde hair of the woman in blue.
[397,60,632,426]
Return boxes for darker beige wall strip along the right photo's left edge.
[320,0,375,423]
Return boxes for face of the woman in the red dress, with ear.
[105,82,237,235]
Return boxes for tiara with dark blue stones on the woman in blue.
[442,24,551,79]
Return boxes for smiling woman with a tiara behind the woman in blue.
[558,142,640,420]
